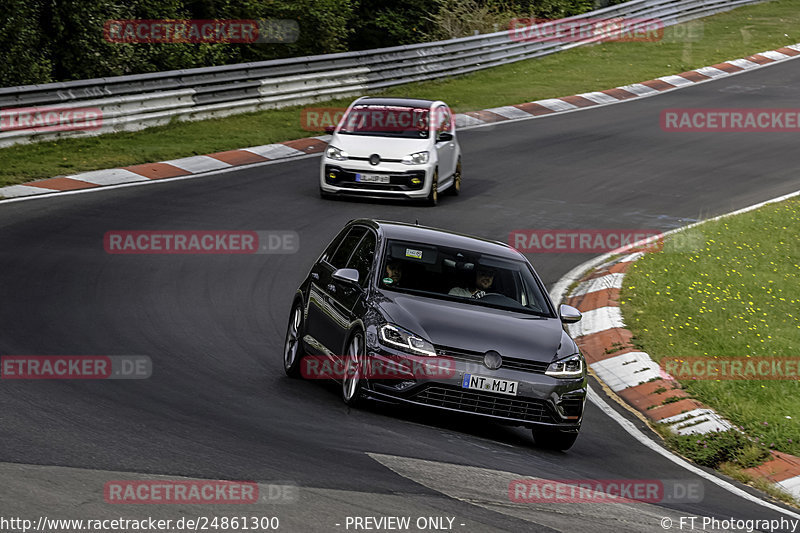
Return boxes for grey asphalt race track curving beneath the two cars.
[0,61,800,531]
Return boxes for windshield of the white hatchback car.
[339,105,430,139]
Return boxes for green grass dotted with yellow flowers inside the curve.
[620,199,800,455]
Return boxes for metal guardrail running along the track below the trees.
[0,0,763,147]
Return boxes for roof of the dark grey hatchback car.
[352,218,524,260]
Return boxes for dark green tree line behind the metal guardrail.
[0,0,623,87]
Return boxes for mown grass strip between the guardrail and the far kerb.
[0,0,800,186]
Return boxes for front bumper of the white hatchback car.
[320,158,433,199]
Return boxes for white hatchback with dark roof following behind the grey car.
[319,97,461,205]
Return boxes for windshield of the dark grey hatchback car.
[378,240,554,317]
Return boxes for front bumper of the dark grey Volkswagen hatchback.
[366,346,587,431]
